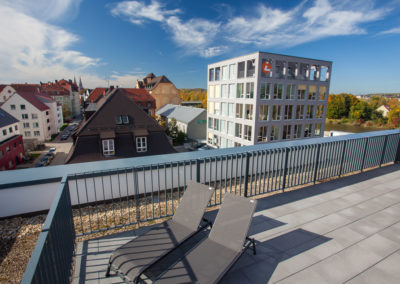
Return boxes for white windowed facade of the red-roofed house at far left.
[1,93,59,142]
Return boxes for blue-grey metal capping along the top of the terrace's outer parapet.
[0,129,400,190]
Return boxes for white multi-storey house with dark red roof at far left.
[1,92,62,143]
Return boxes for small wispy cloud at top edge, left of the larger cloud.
[111,1,180,25]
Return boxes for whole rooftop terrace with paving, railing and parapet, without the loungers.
[0,130,400,283]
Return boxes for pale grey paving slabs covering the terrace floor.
[73,165,400,284]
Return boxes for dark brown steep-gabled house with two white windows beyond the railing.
[67,88,175,163]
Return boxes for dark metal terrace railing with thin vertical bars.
[14,130,400,283]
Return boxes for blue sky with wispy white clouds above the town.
[0,0,400,94]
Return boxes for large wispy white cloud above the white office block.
[226,0,387,47]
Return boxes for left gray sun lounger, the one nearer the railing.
[106,181,214,282]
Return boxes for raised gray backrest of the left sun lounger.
[172,181,214,231]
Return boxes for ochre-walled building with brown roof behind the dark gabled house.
[136,73,181,111]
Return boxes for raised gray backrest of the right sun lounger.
[209,192,257,252]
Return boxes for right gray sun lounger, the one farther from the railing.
[155,193,257,283]
